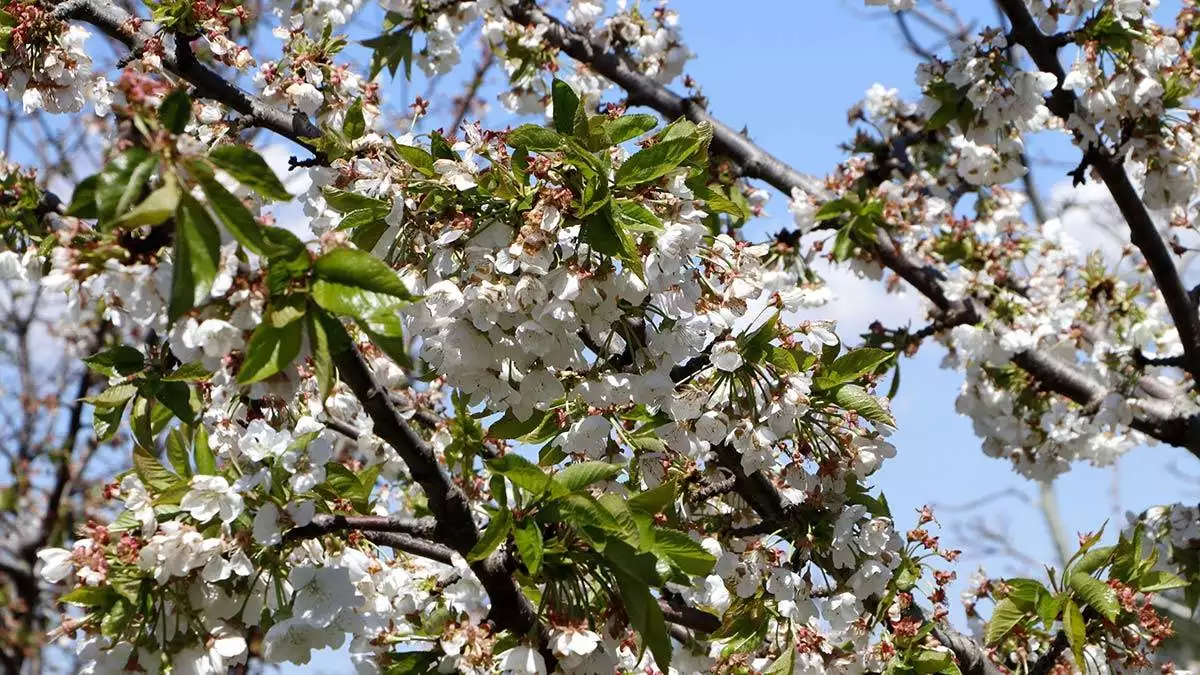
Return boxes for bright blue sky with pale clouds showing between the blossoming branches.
[196,0,1200,673]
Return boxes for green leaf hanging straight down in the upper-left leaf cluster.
[167,195,221,323]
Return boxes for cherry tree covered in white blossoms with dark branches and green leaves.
[0,0,1200,675]
